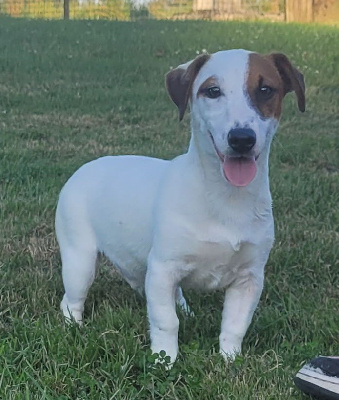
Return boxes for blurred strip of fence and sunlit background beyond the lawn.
[0,0,339,23]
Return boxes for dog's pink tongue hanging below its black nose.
[223,157,257,186]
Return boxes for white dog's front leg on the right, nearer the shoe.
[219,274,263,359]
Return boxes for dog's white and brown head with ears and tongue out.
[166,50,305,186]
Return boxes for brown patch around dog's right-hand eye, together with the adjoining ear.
[247,53,305,119]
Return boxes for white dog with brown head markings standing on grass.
[56,50,305,363]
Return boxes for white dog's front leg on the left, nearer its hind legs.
[145,259,179,363]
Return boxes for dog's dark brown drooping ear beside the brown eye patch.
[268,53,306,112]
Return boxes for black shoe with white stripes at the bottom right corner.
[294,356,339,400]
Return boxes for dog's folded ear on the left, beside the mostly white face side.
[166,54,210,121]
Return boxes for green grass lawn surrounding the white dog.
[0,14,339,400]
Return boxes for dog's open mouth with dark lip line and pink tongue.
[209,132,259,187]
